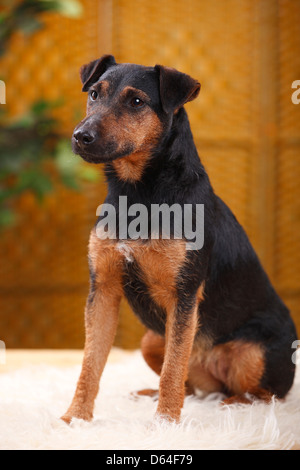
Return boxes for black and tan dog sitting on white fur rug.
[62,55,296,422]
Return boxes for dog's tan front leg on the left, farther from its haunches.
[62,235,122,423]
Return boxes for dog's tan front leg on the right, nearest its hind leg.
[156,303,198,422]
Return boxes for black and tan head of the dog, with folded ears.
[72,55,200,163]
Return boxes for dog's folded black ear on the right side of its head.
[154,65,201,113]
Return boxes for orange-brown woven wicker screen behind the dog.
[0,0,300,348]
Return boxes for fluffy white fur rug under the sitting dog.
[0,351,300,450]
